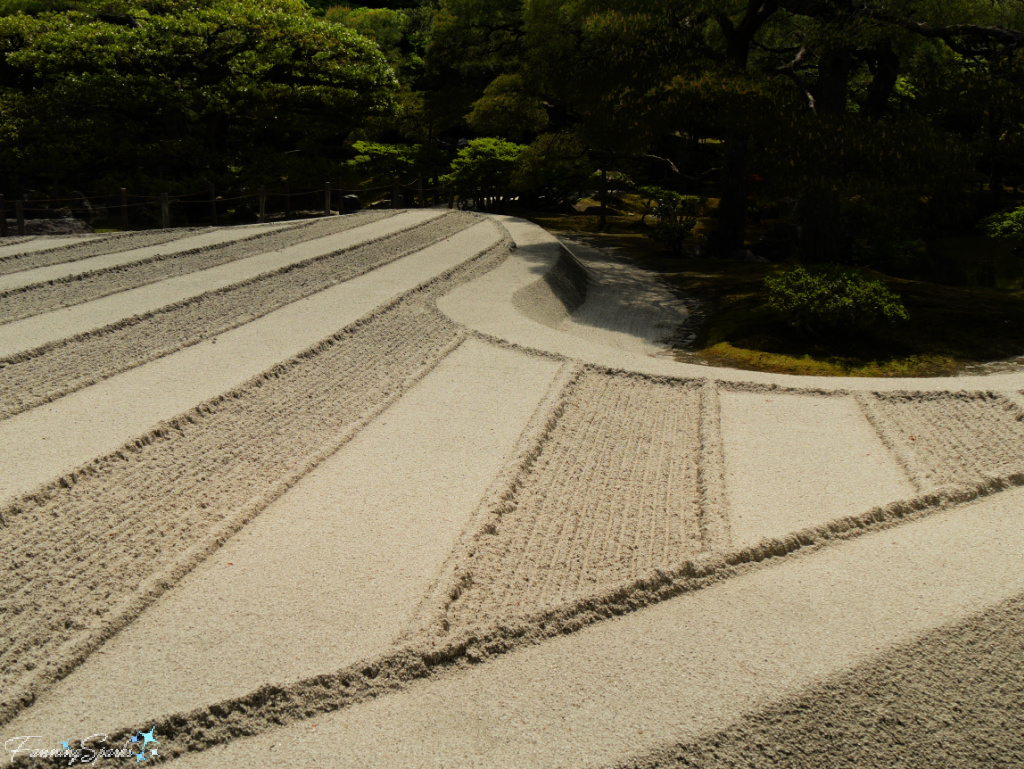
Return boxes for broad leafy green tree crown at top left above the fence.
[0,0,396,191]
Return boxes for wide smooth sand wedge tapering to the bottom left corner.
[5,341,558,739]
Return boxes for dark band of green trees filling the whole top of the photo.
[0,0,1024,262]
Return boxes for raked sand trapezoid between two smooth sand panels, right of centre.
[446,372,701,628]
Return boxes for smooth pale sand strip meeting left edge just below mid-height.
[0,217,501,500]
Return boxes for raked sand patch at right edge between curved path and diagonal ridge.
[861,392,1024,492]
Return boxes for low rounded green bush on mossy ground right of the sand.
[765,265,909,335]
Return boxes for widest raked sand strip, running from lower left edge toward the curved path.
[0,234,507,722]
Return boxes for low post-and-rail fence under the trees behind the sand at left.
[0,174,454,237]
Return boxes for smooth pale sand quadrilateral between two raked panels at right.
[721,392,916,548]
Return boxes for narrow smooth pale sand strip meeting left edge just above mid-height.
[0,211,442,355]
